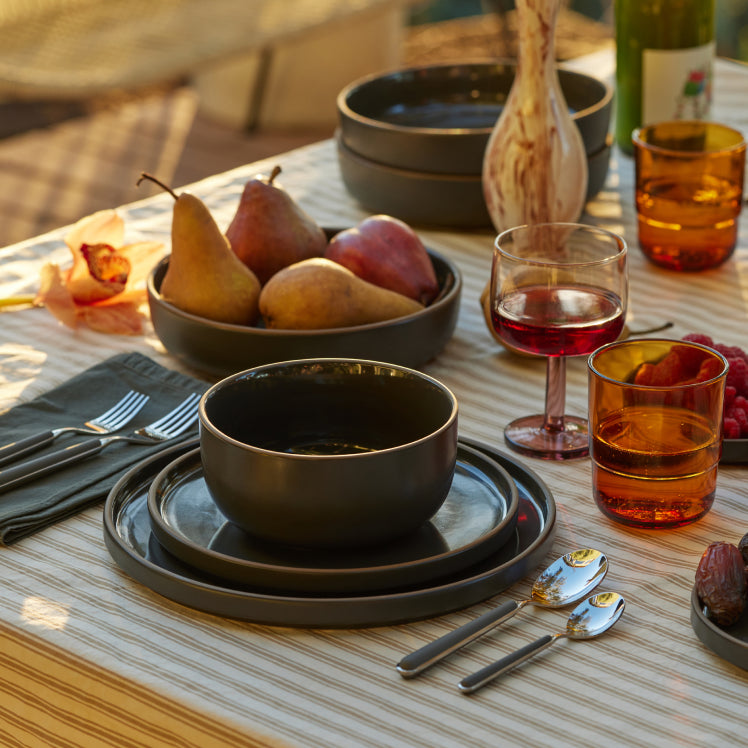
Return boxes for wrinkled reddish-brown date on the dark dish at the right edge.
[696,541,746,626]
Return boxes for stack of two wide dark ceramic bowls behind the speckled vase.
[336,61,613,228]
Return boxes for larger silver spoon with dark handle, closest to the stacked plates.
[397,548,608,678]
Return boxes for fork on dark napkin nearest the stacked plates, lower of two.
[0,394,200,493]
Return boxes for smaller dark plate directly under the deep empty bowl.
[148,444,519,594]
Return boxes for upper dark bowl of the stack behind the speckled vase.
[337,61,613,175]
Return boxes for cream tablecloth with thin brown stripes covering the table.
[0,54,748,748]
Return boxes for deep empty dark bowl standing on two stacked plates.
[199,359,457,548]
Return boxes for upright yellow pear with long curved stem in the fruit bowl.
[138,174,260,325]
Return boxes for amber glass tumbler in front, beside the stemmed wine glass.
[588,339,728,528]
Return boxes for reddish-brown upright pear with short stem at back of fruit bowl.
[226,166,327,285]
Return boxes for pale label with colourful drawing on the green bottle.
[642,41,715,125]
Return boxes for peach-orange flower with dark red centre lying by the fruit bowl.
[35,210,164,335]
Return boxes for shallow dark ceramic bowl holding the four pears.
[147,230,462,377]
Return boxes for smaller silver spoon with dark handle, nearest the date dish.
[458,592,626,693]
